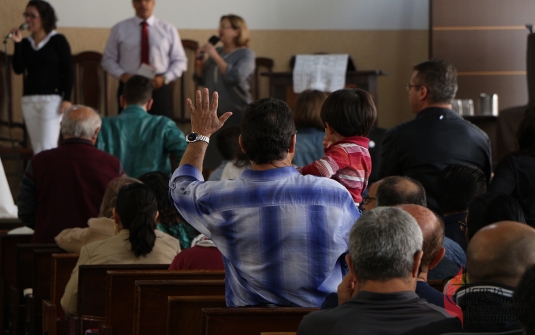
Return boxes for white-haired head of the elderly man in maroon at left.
[61,105,102,140]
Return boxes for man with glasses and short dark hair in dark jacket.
[379,60,491,217]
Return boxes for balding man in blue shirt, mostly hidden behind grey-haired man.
[376,176,466,279]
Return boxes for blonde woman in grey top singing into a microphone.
[193,14,255,125]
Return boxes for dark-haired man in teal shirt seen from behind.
[97,75,186,178]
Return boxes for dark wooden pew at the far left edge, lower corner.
[0,234,33,331]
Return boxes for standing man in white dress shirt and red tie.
[101,0,187,117]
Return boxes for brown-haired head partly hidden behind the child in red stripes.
[293,90,327,130]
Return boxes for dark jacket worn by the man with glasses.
[379,107,492,213]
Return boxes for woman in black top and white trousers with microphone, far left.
[12,0,73,154]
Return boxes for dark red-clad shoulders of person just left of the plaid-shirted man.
[169,234,225,270]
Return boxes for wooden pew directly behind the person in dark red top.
[100,270,225,335]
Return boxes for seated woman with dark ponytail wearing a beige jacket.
[61,183,180,314]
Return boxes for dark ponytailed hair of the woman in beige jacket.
[115,183,157,258]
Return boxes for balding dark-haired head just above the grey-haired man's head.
[376,176,427,207]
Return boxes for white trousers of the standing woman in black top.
[21,95,63,154]
